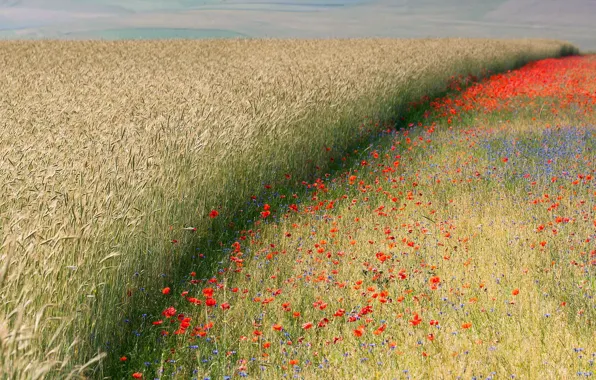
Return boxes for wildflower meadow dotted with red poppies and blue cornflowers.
[117,56,596,379]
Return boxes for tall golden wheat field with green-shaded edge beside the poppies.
[0,39,576,378]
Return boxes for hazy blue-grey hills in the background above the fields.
[0,0,596,49]
